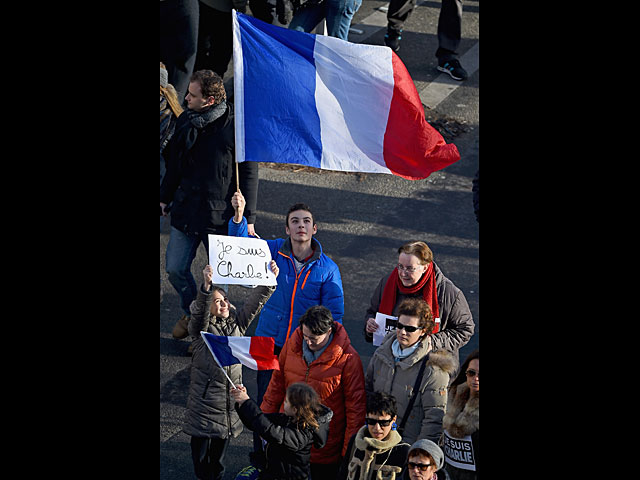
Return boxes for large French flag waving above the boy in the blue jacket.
[233,10,460,180]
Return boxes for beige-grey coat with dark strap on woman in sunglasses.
[364,332,457,444]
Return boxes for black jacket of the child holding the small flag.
[236,399,333,480]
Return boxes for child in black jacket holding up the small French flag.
[231,382,333,480]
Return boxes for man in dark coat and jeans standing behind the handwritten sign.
[160,70,258,338]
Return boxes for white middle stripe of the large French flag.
[313,35,393,173]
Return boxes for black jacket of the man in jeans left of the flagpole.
[160,104,258,235]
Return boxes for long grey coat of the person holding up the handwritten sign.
[183,286,275,438]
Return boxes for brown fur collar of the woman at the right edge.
[442,383,480,438]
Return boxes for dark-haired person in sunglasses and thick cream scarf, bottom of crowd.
[337,392,410,480]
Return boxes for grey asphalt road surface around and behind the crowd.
[160,0,480,480]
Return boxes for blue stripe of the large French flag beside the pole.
[237,14,322,168]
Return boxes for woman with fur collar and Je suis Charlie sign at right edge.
[442,350,480,480]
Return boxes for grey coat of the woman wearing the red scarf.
[364,262,475,368]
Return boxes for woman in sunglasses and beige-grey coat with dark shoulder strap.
[365,298,457,443]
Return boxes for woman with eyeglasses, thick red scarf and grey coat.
[364,242,475,368]
